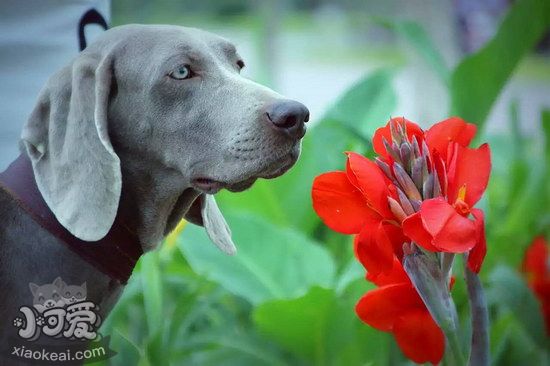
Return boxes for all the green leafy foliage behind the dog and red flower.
[102,0,550,365]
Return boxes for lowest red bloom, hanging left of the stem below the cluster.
[355,258,445,364]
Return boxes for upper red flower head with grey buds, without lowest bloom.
[312,117,491,273]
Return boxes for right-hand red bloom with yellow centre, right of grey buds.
[396,117,491,273]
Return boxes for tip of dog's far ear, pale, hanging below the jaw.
[185,193,237,255]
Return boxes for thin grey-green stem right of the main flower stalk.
[464,260,489,366]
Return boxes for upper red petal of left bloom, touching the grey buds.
[346,152,393,218]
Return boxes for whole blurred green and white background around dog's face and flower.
[0,0,550,366]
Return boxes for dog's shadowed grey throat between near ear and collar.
[119,154,200,251]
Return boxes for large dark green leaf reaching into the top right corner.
[451,0,550,126]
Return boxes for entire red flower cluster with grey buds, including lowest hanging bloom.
[312,117,491,363]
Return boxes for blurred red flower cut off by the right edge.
[522,236,550,336]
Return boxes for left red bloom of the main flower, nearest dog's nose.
[312,153,404,272]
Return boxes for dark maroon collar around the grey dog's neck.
[0,155,143,283]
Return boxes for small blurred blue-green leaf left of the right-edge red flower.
[487,266,548,348]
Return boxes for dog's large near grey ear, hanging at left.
[22,52,122,241]
